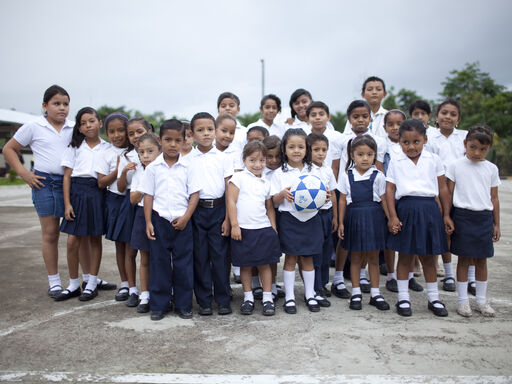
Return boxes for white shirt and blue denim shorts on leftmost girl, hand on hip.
[13,116,75,217]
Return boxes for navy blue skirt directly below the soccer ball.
[279,211,324,256]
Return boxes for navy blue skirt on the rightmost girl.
[450,208,494,259]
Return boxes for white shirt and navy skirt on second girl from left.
[60,138,110,236]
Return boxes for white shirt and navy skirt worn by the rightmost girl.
[446,156,501,258]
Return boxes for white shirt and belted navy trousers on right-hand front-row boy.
[190,147,233,308]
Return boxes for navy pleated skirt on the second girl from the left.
[60,177,105,236]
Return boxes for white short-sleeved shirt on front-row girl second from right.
[386,151,444,200]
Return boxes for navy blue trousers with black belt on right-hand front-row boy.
[192,204,230,308]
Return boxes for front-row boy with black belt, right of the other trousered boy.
[190,112,233,316]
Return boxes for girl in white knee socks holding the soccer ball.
[271,128,323,314]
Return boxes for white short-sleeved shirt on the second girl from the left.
[61,138,111,179]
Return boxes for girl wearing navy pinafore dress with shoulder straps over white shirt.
[338,135,389,310]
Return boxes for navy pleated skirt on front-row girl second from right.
[387,196,448,255]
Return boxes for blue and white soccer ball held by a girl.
[290,175,327,212]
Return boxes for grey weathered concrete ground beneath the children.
[0,181,512,383]
